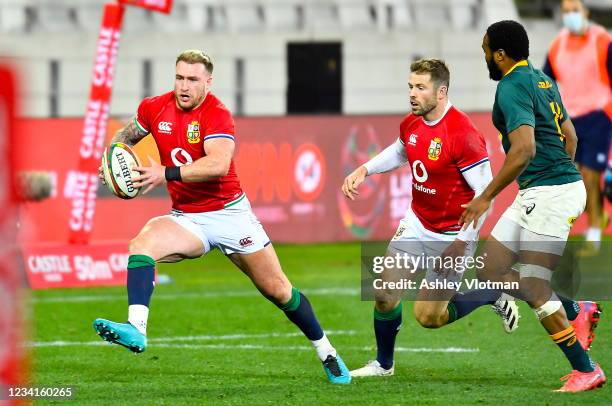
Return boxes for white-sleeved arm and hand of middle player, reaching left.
[342,138,408,200]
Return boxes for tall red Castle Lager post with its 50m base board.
[23,0,172,289]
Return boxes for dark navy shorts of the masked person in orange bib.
[572,110,612,171]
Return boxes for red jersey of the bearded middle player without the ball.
[400,106,489,234]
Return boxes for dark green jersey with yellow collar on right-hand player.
[493,61,582,189]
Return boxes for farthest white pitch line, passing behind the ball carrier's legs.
[30,288,359,303]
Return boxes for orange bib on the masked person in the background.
[548,23,612,117]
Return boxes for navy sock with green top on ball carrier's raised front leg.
[127,255,155,307]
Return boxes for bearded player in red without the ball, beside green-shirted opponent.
[342,59,519,377]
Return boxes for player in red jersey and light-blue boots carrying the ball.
[94,50,351,383]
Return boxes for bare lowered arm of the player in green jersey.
[459,124,536,230]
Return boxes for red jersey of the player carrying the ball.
[136,91,243,213]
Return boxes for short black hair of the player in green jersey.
[487,20,529,61]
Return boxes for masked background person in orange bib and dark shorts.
[543,0,612,252]
